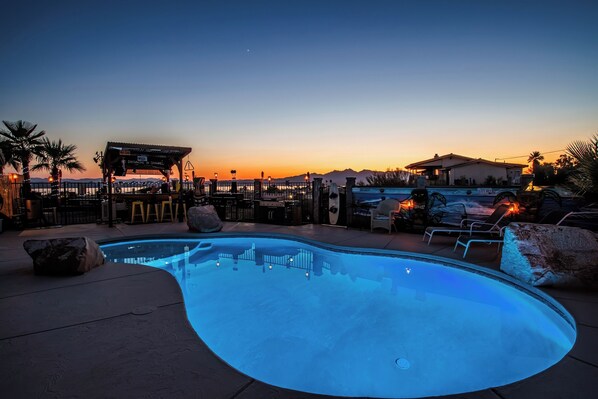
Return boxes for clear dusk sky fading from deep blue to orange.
[0,0,598,178]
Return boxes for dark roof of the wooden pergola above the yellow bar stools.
[102,141,191,176]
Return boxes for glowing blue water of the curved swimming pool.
[102,236,576,398]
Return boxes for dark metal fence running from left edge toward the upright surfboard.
[0,180,312,228]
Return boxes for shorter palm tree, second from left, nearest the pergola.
[31,137,85,197]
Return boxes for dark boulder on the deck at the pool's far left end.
[23,237,105,275]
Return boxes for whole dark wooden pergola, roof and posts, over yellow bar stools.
[102,141,191,227]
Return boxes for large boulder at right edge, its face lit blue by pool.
[500,223,598,287]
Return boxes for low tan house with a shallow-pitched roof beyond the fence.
[405,153,527,186]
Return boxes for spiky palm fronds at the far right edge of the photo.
[567,134,598,196]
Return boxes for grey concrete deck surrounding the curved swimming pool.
[0,222,598,399]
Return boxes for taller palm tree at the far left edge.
[0,121,46,197]
